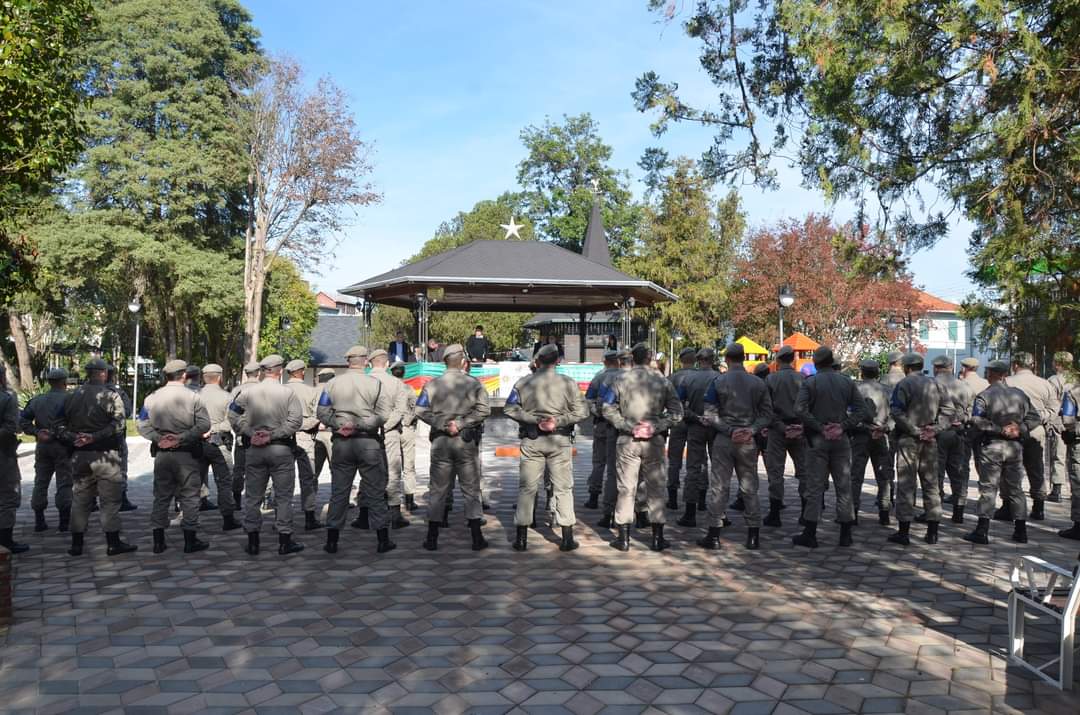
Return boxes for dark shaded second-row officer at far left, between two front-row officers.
[19,367,71,532]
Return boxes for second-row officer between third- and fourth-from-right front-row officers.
[851,360,893,526]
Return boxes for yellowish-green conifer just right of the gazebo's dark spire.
[624,159,746,346]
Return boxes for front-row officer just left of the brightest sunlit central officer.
[416,343,492,551]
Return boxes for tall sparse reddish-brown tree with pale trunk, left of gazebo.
[235,59,380,360]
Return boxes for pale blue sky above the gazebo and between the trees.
[245,0,970,300]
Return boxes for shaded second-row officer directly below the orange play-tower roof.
[764,346,807,526]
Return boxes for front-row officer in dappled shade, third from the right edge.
[889,352,948,545]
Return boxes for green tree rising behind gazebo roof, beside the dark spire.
[517,113,643,260]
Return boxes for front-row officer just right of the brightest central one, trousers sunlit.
[603,342,683,551]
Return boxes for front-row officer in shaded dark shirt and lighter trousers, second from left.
[56,358,138,556]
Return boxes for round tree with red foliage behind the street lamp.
[733,215,919,363]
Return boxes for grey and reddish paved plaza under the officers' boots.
[0,423,1080,715]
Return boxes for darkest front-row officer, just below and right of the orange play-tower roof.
[792,346,867,549]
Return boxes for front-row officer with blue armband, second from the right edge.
[963,360,1042,543]
